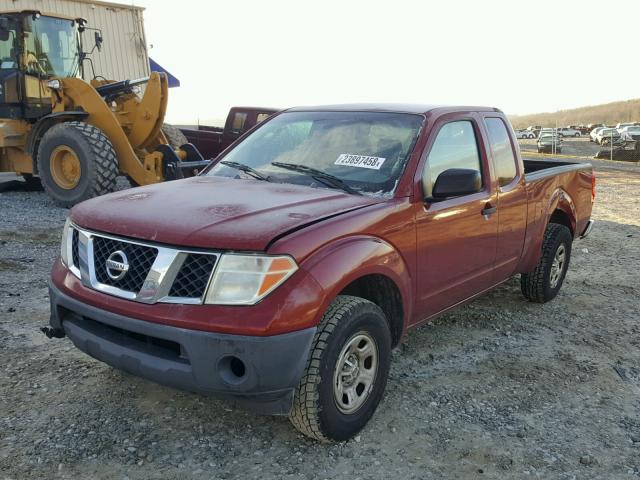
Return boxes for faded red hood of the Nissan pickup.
[71,177,381,250]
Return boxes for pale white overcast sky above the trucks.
[129,0,640,124]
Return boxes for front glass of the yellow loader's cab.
[24,17,80,77]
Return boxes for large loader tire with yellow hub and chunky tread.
[37,122,119,208]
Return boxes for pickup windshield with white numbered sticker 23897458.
[207,112,424,196]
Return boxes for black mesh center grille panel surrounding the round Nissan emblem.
[93,237,158,293]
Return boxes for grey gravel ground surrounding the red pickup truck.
[0,158,640,479]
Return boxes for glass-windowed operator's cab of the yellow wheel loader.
[0,11,83,120]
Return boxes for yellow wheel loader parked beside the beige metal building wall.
[0,10,208,207]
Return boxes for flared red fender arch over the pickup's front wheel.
[302,235,413,333]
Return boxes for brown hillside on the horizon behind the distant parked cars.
[509,98,640,128]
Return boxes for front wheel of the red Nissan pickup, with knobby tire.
[289,295,391,442]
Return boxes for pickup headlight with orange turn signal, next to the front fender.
[205,254,298,305]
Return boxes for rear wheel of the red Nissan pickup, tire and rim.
[520,223,573,303]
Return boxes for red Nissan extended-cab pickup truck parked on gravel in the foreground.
[47,105,595,441]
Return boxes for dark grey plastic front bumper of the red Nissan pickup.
[49,285,316,414]
